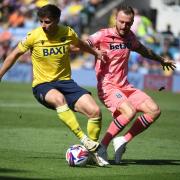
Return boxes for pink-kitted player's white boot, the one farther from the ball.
[113,136,127,164]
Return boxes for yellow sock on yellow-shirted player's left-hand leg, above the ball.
[56,104,85,140]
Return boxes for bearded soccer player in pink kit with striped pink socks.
[87,5,176,164]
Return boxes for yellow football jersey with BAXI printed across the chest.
[18,25,78,87]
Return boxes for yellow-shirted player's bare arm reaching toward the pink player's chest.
[75,39,106,62]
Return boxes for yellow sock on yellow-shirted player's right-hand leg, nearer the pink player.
[87,117,101,141]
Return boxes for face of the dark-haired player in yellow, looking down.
[39,17,58,35]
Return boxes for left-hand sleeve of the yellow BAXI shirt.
[18,32,34,52]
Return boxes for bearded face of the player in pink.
[116,11,134,37]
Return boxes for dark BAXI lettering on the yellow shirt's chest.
[42,46,66,56]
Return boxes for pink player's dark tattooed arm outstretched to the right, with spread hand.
[134,43,176,70]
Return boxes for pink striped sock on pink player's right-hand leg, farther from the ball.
[124,114,154,142]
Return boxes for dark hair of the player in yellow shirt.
[37,4,61,19]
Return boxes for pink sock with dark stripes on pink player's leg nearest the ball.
[101,115,129,148]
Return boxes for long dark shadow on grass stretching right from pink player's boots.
[109,159,180,166]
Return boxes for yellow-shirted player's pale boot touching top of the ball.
[81,136,99,152]
